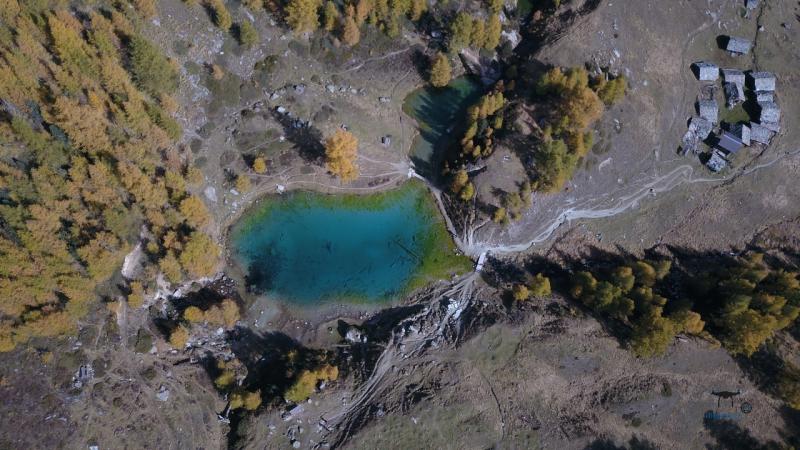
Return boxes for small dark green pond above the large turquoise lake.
[403,77,483,177]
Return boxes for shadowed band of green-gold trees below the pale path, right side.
[486,248,800,408]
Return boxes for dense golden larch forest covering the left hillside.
[0,0,219,351]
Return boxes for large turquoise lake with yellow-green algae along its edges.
[230,185,468,306]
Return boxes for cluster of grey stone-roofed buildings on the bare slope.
[681,53,781,172]
